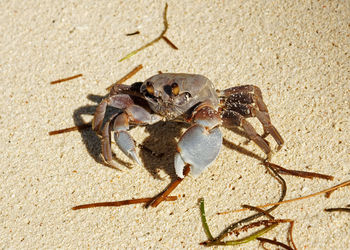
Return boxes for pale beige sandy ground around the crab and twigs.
[0,0,350,249]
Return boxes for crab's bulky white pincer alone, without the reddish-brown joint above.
[174,124,222,178]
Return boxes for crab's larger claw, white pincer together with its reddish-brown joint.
[174,104,222,178]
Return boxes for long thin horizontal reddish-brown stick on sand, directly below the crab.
[72,196,177,210]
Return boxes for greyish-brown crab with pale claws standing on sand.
[92,73,283,179]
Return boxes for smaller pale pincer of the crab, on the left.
[114,131,142,166]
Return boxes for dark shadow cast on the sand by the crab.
[73,94,263,181]
